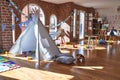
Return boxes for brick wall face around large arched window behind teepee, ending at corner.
[13,0,58,39]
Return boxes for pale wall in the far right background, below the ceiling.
[96,7,120,29]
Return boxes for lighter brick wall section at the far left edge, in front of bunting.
[0,0,12,50]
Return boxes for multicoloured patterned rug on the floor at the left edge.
[0,56,20,72]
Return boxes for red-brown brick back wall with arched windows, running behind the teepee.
[13,0,95,37]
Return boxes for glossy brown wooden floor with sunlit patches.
[0,44,120,80]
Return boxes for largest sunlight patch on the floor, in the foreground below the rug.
[1,67,74,80]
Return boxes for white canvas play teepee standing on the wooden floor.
[9,14,60,60]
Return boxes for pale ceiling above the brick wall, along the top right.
[42,0,120,8]
